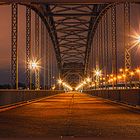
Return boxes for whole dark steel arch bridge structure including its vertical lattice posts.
[0,0,139,88]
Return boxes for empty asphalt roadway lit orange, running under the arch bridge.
[0,92,140,140]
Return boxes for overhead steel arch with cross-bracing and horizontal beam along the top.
[0,0,139,85]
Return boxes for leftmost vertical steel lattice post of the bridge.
[11,3,18,89]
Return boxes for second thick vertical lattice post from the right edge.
[111,4,117,88]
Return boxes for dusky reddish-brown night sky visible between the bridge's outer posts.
[0,5,140,84]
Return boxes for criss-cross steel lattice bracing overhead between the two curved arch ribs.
[47,4,108,80]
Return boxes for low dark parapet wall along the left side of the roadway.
[0,90,64,106]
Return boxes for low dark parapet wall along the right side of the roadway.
[83,89,140,106]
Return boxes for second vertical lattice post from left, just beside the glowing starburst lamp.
[26,7,31,89]
